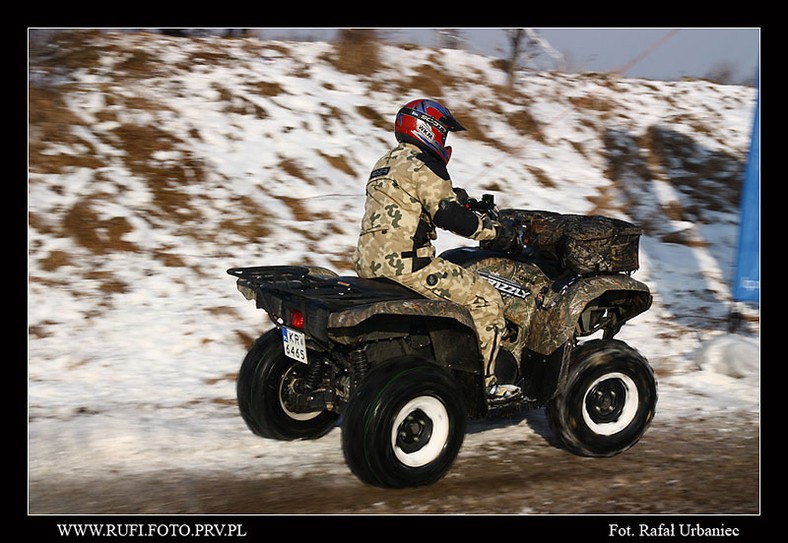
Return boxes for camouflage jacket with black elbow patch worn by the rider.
[353,143,496,277]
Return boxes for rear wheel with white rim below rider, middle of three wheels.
[342,357,466,488]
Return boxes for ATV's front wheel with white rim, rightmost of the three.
[547,339,657,457]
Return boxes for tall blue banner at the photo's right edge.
[733,88,761,302]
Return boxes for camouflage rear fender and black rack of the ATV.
[228,266,481,374]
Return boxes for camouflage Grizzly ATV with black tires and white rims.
[228,196,657,488]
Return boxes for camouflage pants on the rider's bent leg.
[390,258,506,377]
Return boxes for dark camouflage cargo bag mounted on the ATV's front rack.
[502,211,643,275]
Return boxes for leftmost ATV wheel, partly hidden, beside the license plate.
[236,329,339,441]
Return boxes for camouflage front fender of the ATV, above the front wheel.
[525,275,652,355]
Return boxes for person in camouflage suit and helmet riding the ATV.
[353,99,519,398]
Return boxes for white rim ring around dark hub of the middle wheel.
[391,396,450,468]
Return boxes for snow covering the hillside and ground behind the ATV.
[28,33,760,492]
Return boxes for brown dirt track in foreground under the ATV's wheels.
[30,415,760,515]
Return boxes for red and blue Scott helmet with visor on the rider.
[394,98,465,164]
